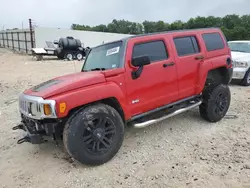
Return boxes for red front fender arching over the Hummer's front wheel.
[51,82,130,119]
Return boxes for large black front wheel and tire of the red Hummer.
[63,104,124,166]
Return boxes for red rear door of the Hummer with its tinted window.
[173,34,204,99]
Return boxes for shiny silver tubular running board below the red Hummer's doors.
[133,101,202,128]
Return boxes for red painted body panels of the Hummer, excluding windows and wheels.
[25,29,231,119]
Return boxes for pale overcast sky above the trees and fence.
[0,0,250,30]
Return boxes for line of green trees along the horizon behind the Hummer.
[71,14,250,40]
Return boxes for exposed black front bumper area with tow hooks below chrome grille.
[12,115,62,144]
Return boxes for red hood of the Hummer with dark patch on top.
[24,71,106,99]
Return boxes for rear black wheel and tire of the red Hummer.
[199,83,231,123]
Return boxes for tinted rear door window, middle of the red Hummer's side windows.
[174,37,200,56]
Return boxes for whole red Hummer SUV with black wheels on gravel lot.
[13,28,232,165]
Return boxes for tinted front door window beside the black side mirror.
[133,41,168,62]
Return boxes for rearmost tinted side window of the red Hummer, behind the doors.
[202,33,225,52]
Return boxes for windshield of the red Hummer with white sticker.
[82,41,123,71]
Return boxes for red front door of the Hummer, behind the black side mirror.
[125,36,178,115]
